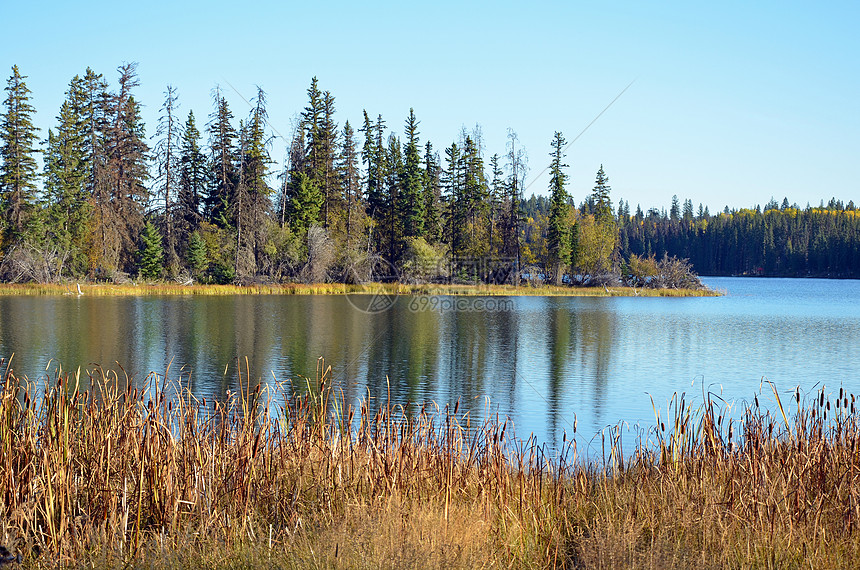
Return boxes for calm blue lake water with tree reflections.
[0,278,860,450]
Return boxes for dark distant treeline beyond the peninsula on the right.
[523,196,860,278]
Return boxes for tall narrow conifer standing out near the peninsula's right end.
[547,131,570,285]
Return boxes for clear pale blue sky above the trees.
[0,0,860,211]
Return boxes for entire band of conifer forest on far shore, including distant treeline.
[0,64,860,286]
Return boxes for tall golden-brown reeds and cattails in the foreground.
[0,363,860,568]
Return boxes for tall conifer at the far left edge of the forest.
[0,65,39,249]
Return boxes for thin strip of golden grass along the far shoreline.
[0,283,719,297]
